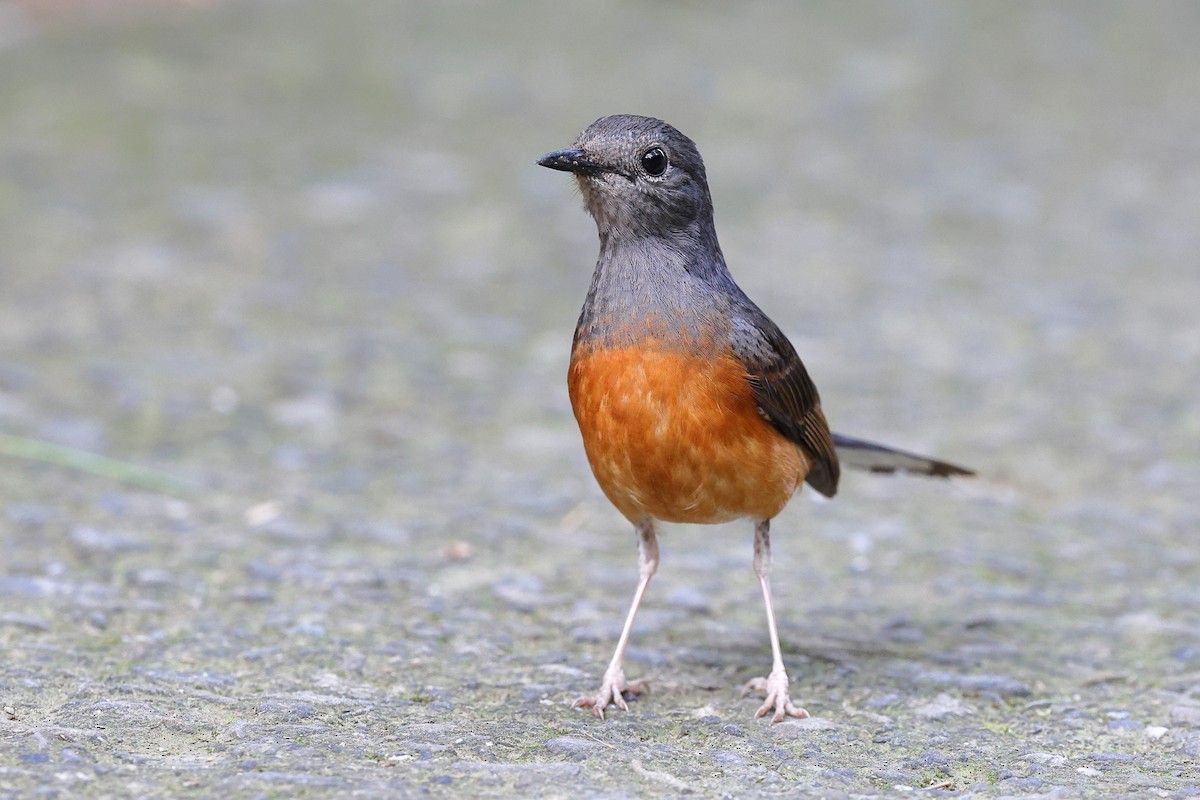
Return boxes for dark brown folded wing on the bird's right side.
[731,305,840,498]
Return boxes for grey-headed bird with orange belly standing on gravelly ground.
[538,114,973,722]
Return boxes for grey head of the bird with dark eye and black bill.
[538,114,713,239]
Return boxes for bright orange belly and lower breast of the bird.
[568,347,810,523]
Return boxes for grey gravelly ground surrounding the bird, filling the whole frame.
[0,0,1200,798]
